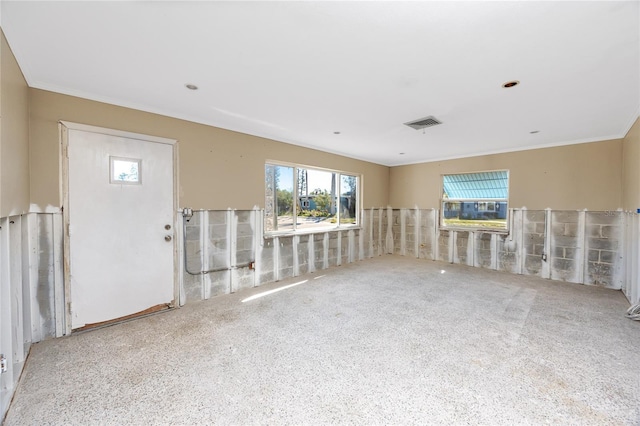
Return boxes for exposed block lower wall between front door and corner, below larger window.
[181,209,370,304]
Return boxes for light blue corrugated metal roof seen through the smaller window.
[443,170,509,200]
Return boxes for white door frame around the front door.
[58,120,182,335]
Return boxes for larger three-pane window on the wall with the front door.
[264,163,360,234]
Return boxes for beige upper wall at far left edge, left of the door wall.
[0,33,29,217]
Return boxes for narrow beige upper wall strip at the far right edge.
[622,118,640,211]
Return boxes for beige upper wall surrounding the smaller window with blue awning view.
[389,139,624,210]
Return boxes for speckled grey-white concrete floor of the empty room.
[6,256,640,426]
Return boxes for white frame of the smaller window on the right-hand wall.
[438,169,511,234]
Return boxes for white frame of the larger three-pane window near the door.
[262,160,363,238]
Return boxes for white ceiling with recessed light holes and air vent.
[1,0,640,166]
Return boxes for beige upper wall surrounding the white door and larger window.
[30,89,389,211]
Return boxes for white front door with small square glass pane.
[65,125,175,329]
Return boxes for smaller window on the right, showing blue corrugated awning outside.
[440,170,509,231]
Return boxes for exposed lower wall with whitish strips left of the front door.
[0,213,65,419]
